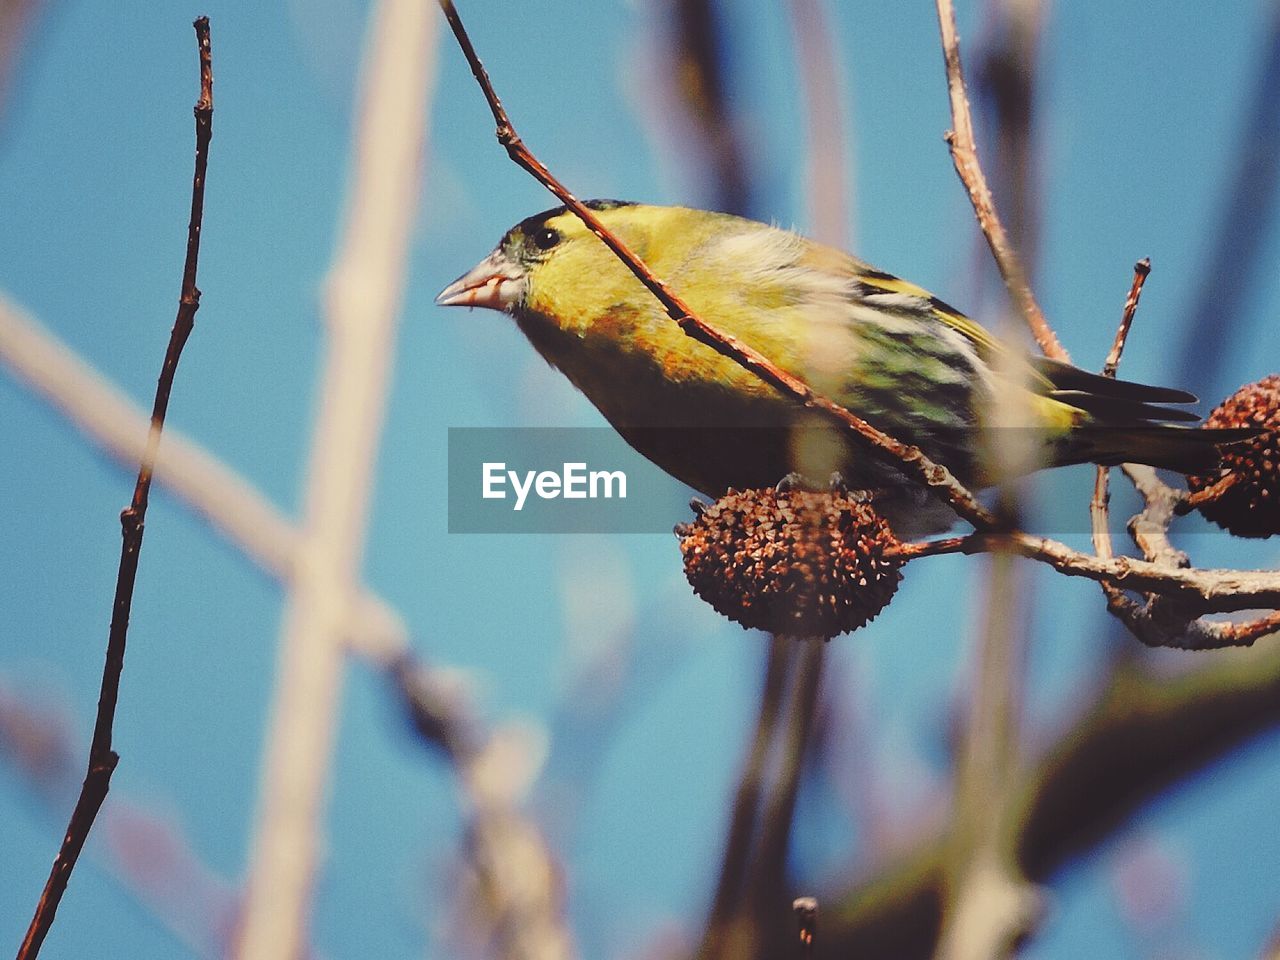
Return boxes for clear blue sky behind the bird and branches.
[0,0,1280,960]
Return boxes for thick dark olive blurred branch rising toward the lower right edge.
[823,649,1280,960]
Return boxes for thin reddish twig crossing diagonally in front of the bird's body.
[439,0,997,530]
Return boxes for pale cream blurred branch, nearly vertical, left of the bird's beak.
[236,0,435,960]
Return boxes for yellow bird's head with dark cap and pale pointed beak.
[435,200,640,312]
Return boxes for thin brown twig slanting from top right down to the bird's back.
[937,0,1070,361]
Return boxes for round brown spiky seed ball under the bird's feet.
[676,489,902,640]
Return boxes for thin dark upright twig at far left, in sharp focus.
[18,17,214,960]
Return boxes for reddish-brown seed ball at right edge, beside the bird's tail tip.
[1187,374,1280,538]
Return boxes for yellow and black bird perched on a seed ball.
[436,200,1240,532]
